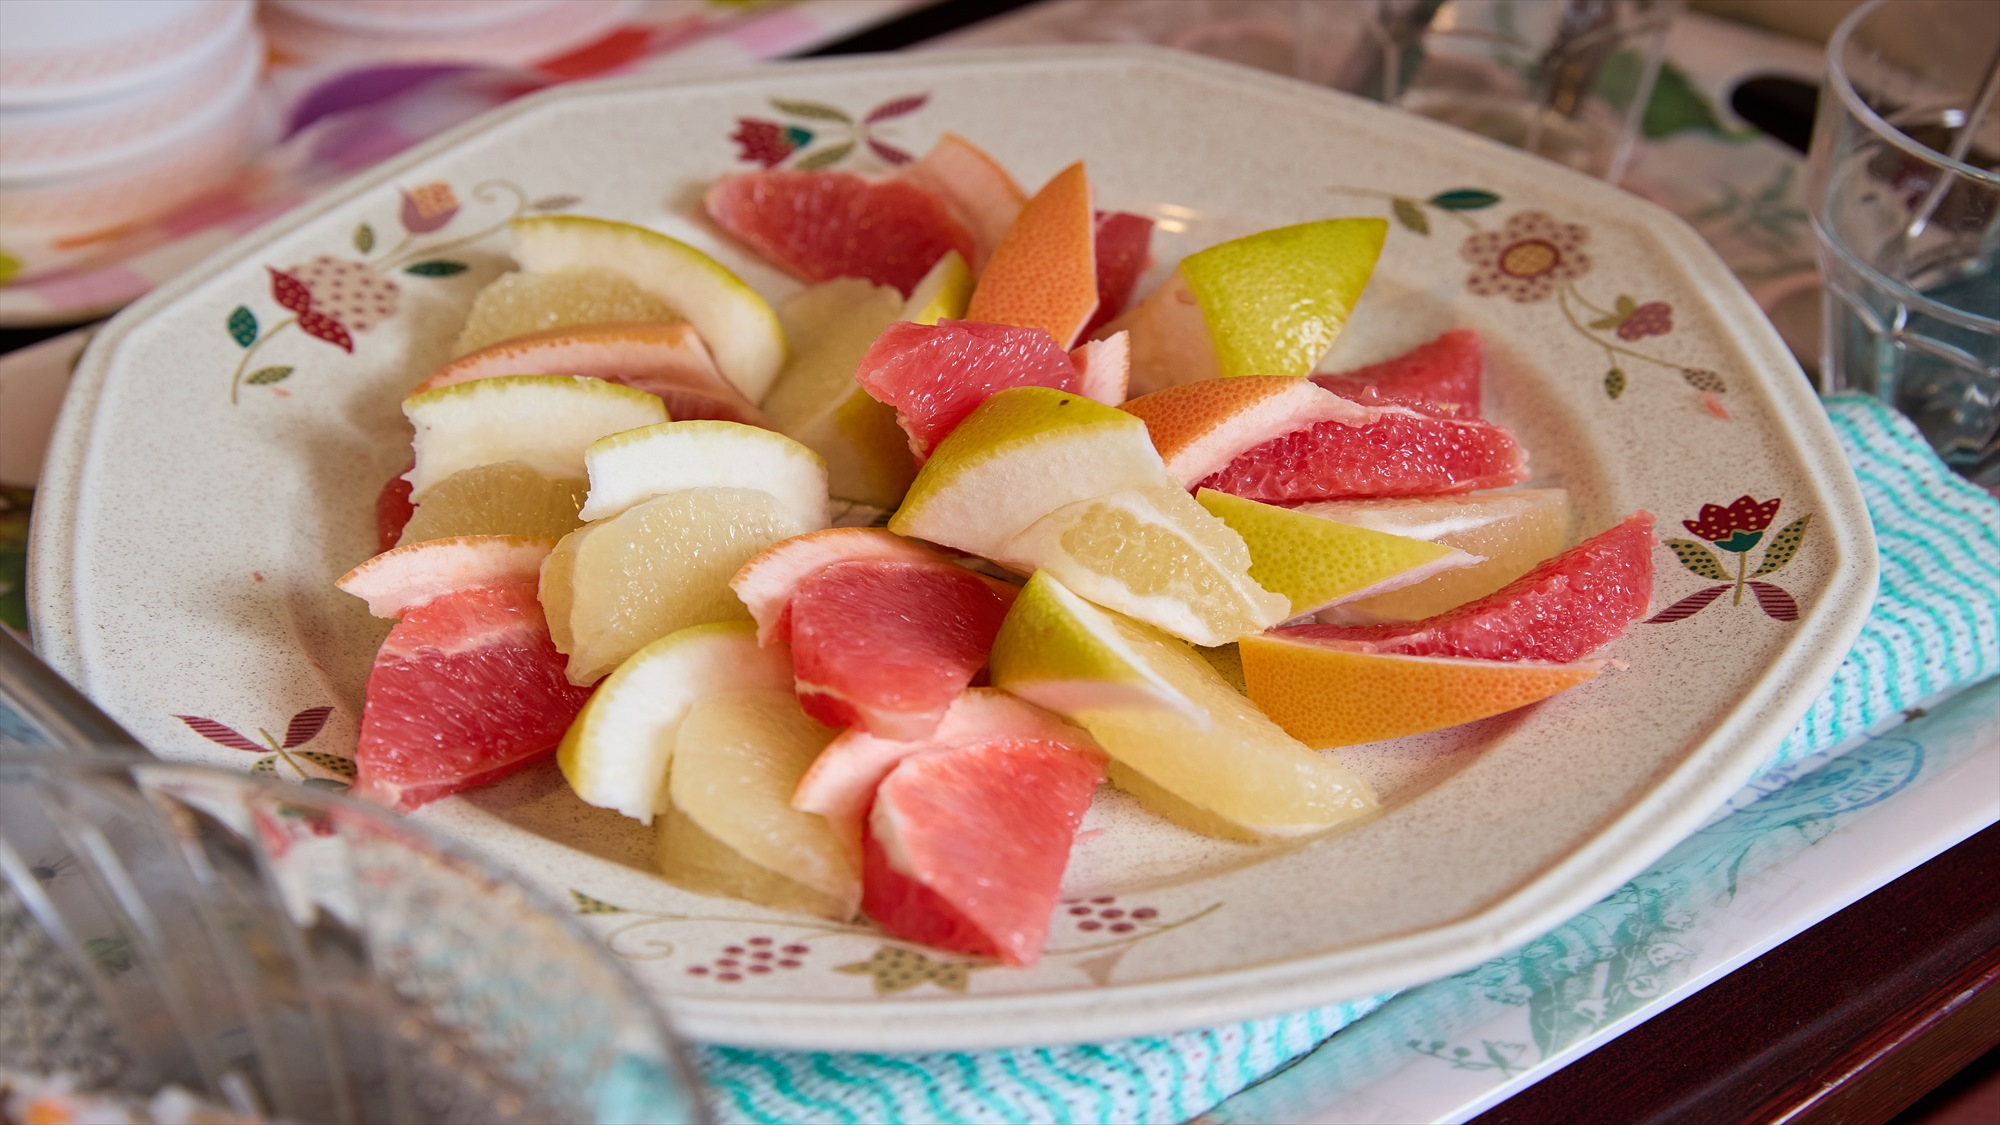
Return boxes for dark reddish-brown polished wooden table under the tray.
[0,0,2000,1125]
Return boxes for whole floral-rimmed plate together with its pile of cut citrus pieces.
[32,50,1874,1049]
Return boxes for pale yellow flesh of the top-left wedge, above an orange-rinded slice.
[452,268,680,354]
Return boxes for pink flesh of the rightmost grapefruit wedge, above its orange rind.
[1280,512,1654,665]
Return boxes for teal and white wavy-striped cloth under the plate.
[694,396,2000,1123]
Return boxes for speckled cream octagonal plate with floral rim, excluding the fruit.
[30,48,1876,1049]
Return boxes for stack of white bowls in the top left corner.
[0,0,264,282]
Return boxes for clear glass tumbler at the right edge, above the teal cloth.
[1806,0,2000,476]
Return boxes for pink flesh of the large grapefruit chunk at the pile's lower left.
[354,583,590,811]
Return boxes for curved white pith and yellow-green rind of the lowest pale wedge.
[556,621,792,825]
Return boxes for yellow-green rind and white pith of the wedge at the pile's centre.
[888,386,1172,558]
